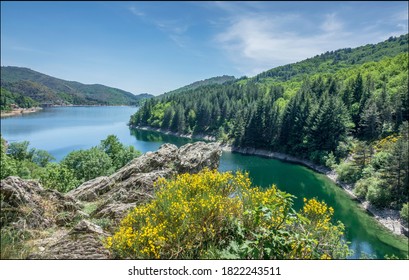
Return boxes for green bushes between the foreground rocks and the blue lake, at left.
[0,135,141,192]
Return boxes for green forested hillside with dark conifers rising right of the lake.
[130,34,409,214]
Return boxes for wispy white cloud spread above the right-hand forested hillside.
[215,4,407,76]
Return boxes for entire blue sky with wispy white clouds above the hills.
[1,1,408,95]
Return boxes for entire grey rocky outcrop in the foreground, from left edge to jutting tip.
[0,142,221,259]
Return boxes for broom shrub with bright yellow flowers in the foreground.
[105,167,348,259]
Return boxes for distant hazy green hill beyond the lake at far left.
[1,66,152,105]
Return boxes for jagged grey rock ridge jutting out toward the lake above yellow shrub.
[68,142,221,224]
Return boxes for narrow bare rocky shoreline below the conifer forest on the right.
[131,126,408,237]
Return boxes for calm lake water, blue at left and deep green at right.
[1,107,408,258]
